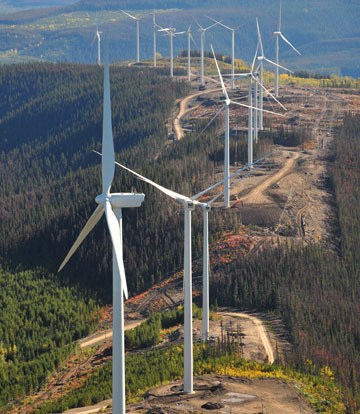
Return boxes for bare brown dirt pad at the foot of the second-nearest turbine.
[128,376,315,414]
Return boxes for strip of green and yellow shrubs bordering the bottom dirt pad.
[36,340,344,414]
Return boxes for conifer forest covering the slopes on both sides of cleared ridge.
[0,59,360,412]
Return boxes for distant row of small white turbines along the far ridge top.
[93,2,300,98]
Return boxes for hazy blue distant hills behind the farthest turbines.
[0,0,360,77]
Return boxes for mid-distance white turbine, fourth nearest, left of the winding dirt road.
[211,45,279,208]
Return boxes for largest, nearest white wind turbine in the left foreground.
[58,58,145,414]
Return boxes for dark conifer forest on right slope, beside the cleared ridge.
[211,115,360,412]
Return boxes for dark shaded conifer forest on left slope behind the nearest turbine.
[0,64,256,301]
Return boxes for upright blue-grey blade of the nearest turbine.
[102,58,115,194]
